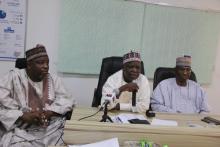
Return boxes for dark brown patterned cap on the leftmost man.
[25,44,48,61]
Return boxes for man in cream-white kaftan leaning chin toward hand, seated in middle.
[101,52,150,112]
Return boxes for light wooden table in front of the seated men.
[64,107,220,147]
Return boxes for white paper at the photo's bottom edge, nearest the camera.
[68,138,119,147]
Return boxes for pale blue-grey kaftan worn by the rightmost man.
[151,78,208,113]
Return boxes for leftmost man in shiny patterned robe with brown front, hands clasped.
[0,46,74,147]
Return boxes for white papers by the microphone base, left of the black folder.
[111,113,147,123]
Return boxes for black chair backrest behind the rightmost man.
[153,67,197,89]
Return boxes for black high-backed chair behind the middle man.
[92,56,144,107]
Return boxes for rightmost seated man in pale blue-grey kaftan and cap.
[151,56,209,113]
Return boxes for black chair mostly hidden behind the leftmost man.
[15,58,72,120]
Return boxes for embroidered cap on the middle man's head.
[123,51,141,64]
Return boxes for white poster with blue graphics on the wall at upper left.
[0,0,27,61]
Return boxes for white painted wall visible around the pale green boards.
[0,0,220,114]
